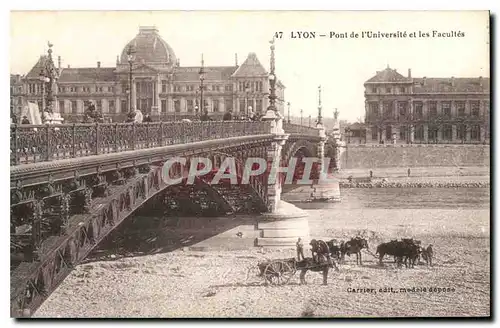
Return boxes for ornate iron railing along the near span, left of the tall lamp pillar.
[10,121,270,165]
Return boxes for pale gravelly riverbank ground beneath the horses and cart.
[35,209,490,318]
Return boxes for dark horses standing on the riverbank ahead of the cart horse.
[310,236,434,268]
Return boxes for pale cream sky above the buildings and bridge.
[9,11,490,121]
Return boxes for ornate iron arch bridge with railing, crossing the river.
[10,121,342,317]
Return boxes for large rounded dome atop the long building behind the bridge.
[120,27,177,64]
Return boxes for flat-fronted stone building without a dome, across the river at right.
[364,67,490,143]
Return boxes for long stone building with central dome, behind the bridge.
[11,27,285,122]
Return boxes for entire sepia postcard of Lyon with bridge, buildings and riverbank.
[9,11,491,319]
